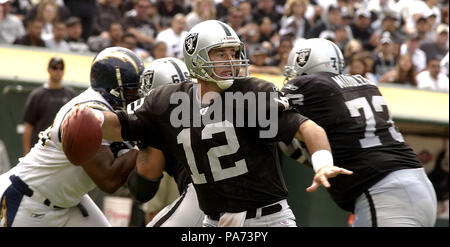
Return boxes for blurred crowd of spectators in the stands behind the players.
[0,0,449,92]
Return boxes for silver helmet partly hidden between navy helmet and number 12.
[140,57,191,96]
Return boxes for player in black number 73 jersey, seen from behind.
[282,39,436,227]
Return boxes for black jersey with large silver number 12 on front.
[118,78,307,214]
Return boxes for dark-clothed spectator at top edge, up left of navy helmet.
[92,0,122,35]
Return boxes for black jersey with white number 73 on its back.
[281,72,422,211]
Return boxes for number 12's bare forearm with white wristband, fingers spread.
[295,120,353,192]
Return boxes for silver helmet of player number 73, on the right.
[283,38,345,80]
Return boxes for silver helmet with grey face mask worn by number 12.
[183,20,248,90]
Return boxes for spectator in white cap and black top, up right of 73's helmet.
[350,8,375,51]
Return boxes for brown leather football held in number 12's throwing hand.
[61,107,102,166]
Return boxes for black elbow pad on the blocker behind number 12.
[128,168,163,203]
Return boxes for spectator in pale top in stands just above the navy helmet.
[124,0,158,49]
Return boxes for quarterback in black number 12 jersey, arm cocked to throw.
[69,20,351,226]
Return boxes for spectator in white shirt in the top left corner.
[0,0,25,44]
